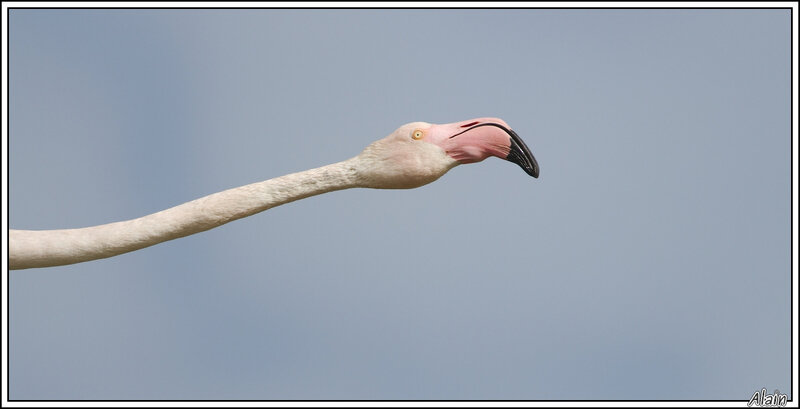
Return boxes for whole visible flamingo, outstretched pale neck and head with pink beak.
[8,118,539,270]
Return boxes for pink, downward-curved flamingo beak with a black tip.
[425,118,539,178]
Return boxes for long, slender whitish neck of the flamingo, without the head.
[9,157,363,270]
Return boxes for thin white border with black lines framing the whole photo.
[0,2,800,408]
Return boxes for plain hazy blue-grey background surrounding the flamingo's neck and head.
[8,9,791,400]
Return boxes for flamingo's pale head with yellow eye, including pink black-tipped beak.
[359,118,539,189]
